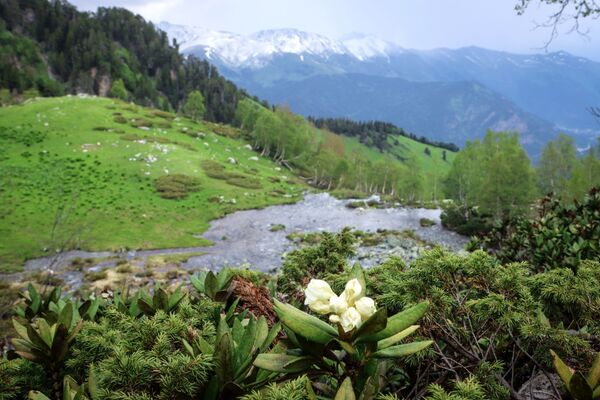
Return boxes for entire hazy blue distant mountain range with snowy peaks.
[158,22,600,155]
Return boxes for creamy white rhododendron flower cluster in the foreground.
[304,279,376,332]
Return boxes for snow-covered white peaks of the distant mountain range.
[158,22,401,69]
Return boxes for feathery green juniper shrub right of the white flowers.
[371,249,600,399]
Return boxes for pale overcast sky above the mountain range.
[71,0,600,61]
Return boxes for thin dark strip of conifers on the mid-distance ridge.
[308,117,459,152]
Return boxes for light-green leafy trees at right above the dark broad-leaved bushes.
[445,132,600,221]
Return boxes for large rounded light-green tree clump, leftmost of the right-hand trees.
[445,131,535,220]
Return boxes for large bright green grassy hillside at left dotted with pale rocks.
[0,97,303,271]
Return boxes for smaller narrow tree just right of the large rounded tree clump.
[537,133,577,198]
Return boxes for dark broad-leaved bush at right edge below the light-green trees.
[480,189,600,272]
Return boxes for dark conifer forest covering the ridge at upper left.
[0,0,245,123]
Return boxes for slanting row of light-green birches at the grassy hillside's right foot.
[236,99,425,201]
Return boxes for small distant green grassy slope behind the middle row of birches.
[344,136,456,200]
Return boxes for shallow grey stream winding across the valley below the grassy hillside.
[10,193,467,284]
